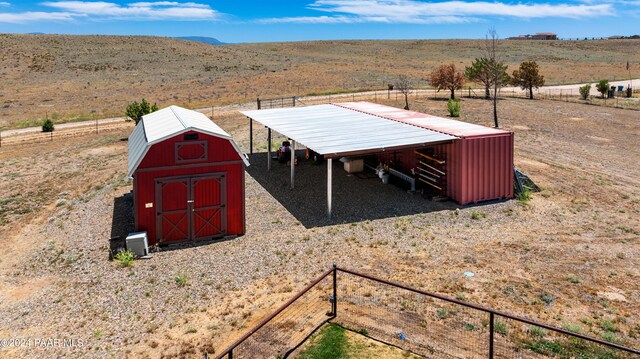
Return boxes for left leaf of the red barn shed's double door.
[156,178,190,244]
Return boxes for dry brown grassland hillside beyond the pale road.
[0,34,640,130]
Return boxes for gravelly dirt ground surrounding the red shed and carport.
[0,97,640,358]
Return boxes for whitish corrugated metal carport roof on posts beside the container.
[240,105,456,157]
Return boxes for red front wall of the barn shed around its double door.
[134,133,245,245]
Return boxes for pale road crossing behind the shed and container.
[2,79,640,137]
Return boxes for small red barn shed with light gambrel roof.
[129,106,249,245]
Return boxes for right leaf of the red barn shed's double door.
[191,174,227,240]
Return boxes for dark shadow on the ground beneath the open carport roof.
[247,152,458,228]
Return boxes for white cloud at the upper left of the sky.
[0,1,220,23]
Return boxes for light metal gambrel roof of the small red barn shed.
[128,106,249,177]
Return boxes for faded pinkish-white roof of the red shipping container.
[336,102,510,138]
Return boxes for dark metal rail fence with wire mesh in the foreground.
[212,266,640,359]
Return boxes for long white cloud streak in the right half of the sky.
[259,0,615,24]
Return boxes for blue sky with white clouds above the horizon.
[0,0,640,42]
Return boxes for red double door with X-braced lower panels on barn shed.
[156,173,227,244]
